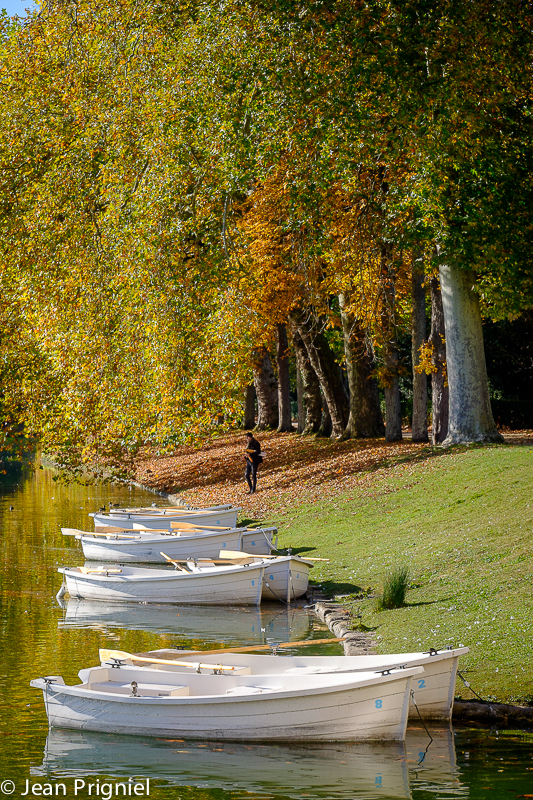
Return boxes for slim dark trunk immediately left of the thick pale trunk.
[429,278,448,444]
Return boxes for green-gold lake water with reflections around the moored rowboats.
[0,470,533,800]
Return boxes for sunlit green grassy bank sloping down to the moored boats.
[271,445,533,703]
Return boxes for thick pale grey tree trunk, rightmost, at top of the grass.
[440,265,503,445]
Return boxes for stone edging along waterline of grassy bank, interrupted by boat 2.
[313,601,533,729]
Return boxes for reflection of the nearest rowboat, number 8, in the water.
[31,729,411,800]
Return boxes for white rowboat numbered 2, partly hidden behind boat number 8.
[127,647,468,720]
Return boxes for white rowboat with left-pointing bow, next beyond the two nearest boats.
[59,564,264,605]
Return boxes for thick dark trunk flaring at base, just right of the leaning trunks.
[339,294,385,439]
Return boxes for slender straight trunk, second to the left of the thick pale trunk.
[411,259,429,442]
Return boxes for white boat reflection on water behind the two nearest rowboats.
[58,598,316,645]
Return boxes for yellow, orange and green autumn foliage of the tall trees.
[0,0,533,472]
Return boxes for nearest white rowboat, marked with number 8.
[31,667,422,742]
